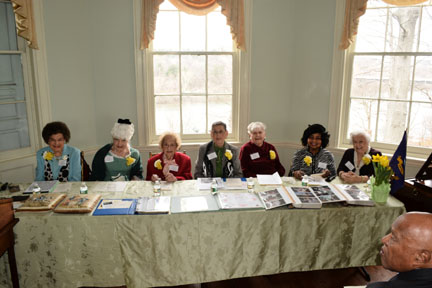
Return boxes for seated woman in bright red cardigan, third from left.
[146,132,192,182]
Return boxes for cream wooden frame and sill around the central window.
[133,0,252,146]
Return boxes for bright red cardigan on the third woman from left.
[146,152,192,180]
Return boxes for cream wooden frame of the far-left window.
[0,0,51,162]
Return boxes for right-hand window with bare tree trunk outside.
[340,0,432,155]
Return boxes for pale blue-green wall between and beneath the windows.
[0,0,426,182]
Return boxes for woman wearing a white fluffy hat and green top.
[90,119,143,181]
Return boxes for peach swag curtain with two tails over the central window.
[141,0,246,50]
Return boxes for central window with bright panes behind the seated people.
[144,1,245,143]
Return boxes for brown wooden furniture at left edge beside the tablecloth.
[0,199,19,288]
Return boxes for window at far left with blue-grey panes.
[0,2,31,152]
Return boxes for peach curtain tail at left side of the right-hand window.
[339,0,367,49]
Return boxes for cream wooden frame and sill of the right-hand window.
[329,1,432,159]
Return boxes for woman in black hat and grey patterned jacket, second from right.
[290,124,336,180]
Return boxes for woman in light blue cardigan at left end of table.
[35,121,81,182]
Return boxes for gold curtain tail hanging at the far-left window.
[11,0,39,49]
